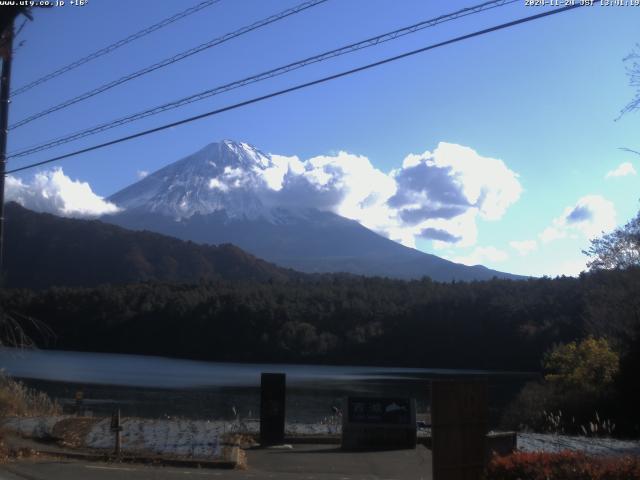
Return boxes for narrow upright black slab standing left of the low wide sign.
[260,373,286,445]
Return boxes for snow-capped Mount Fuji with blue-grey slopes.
[101,140,523,281]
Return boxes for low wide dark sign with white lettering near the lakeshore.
[342,397,417,449]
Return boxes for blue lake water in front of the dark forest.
[0,349,531,422]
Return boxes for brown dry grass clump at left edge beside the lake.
[0,371,62,419]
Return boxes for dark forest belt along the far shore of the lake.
[0,268,640,370]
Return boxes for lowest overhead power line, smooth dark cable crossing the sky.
[7,3,582,174]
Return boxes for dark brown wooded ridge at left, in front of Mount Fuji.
[5,203,298,288]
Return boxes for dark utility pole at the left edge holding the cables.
[0,20,13,285]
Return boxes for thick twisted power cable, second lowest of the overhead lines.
[8,0,519,158]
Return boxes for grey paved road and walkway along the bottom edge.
[0,445,431,480]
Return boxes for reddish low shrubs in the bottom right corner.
[486,451,640,480]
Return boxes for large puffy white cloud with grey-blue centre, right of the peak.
[388,142,522,248]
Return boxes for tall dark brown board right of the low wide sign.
[431,380,488,480]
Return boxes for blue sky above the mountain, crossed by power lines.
[9,0,640,276]
